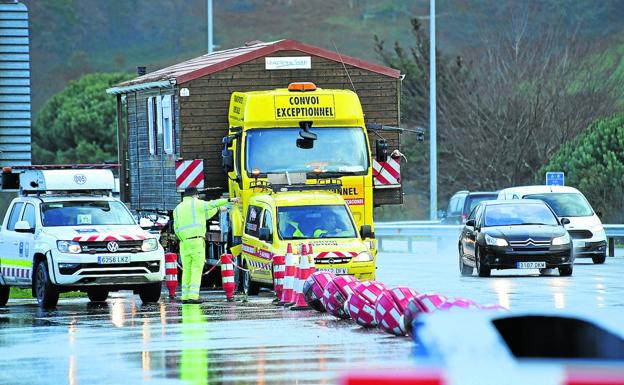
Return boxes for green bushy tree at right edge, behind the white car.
[535,113,624,223]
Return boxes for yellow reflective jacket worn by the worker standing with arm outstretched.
[173,197,228,241]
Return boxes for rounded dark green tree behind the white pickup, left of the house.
[33,73,131,164]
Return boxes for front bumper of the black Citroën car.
[482,246,574,269]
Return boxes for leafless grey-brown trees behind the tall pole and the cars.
[376,3,624,216]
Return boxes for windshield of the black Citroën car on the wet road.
[484,203,558,227]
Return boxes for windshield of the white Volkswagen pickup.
[41,201,136,227]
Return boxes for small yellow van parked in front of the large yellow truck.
[240,191,376,295]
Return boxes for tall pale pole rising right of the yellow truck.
[429,0,438,221]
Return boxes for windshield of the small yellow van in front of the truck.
[277,205,357,239]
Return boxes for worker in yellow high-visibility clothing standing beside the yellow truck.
[173,187,238,303]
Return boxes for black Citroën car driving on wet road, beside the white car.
[459,199,574,277]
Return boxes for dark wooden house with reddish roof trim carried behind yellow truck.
[107,40,402,210]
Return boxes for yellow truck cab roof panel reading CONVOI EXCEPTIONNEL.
[229,86,364,129]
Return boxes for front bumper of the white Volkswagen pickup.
[50,249,165,286]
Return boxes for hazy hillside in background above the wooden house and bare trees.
[21,0,624,112]
